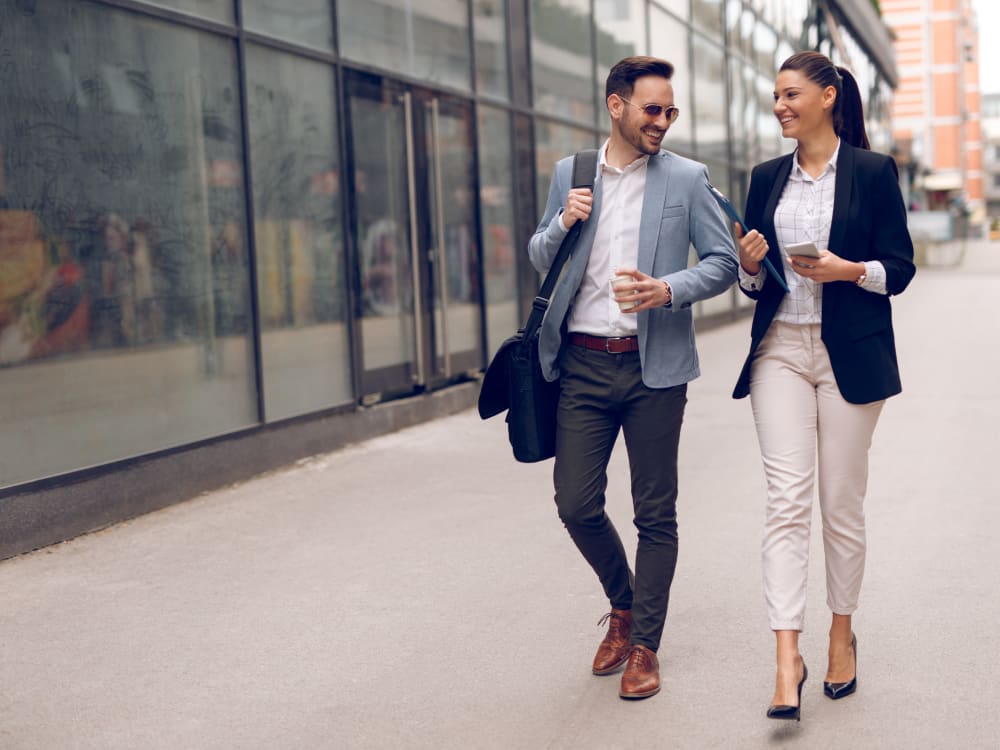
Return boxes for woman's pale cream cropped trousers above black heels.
[750,321,885,630]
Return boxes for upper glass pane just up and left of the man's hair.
[531,0,592,125]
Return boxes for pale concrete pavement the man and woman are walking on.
[0,238,1000,750]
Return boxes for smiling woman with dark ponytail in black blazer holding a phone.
[733,52,915,720]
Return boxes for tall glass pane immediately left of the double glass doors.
[247,46,353,421]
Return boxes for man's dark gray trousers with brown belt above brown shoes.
[554,345,687,651]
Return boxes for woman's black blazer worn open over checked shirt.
[733,141,916,404]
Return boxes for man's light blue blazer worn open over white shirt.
[528,151,738,388]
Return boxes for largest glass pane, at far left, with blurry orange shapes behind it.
[0,0,257,484]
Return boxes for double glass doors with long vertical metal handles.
[346,72,482,402]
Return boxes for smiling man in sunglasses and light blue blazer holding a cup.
[528,57,737,698]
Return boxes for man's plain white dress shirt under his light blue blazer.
[559,141,649,336]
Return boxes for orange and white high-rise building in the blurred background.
[880,0,984,217]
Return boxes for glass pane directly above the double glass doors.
[337,0,472,91]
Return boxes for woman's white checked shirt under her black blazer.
[739,141,887,325]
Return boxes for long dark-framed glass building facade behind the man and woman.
[0,0,893,548]
